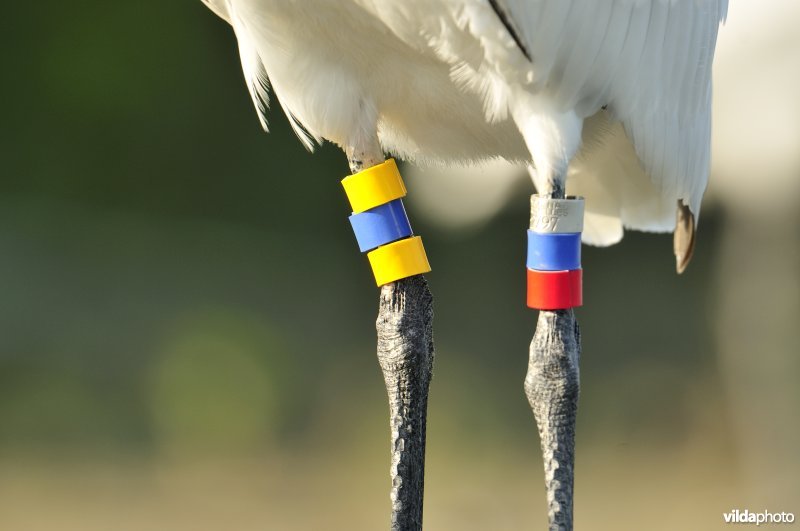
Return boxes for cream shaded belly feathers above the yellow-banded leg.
[211,0,528,164]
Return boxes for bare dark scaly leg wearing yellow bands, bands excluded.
[346,139,434,531]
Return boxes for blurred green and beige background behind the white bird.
[0,0,800,531]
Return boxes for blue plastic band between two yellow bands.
[350,199,411,253]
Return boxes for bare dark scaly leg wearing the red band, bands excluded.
[525,183,581,531]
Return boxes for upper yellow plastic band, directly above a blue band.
[342,159,406,214]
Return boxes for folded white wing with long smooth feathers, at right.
[482,0,727,230]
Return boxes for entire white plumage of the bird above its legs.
[204,0,727,254]
